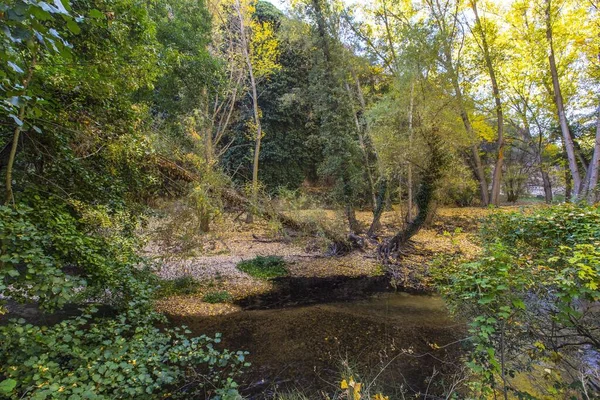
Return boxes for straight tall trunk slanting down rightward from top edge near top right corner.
[546,0,581,196]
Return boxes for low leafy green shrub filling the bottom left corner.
[0,309,249,400]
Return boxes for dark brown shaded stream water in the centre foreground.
[171,276,467,399]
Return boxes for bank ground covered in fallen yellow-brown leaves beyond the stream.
[146,206,517,316]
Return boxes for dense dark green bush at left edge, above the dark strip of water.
[0,200,147,310]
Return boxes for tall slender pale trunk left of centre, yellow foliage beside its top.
[236,0,262,223]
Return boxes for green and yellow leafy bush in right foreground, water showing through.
[437,205,600,397]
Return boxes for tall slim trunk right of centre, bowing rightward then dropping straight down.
[471,0,504,206]
